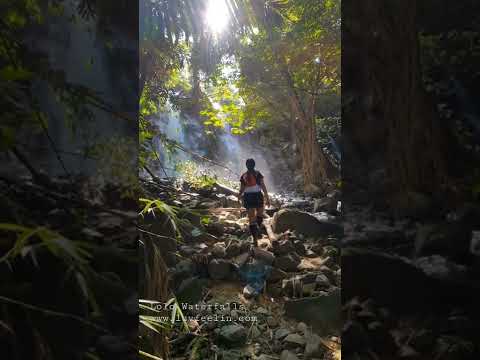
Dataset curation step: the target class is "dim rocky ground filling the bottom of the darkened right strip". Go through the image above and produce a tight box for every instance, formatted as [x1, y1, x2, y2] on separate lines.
[342, 204, 480, 359]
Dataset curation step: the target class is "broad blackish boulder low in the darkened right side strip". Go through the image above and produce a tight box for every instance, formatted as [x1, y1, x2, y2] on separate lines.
[342, 248, 480, 313]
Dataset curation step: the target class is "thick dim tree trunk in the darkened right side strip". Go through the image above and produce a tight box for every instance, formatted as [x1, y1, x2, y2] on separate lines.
[342, 0, 448, 207]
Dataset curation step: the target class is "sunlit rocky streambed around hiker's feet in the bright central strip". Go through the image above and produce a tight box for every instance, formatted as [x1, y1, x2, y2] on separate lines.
[143, 180, 343, 360]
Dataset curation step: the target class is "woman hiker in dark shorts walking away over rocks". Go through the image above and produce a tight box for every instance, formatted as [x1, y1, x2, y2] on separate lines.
[238, 159, 270, 246]
